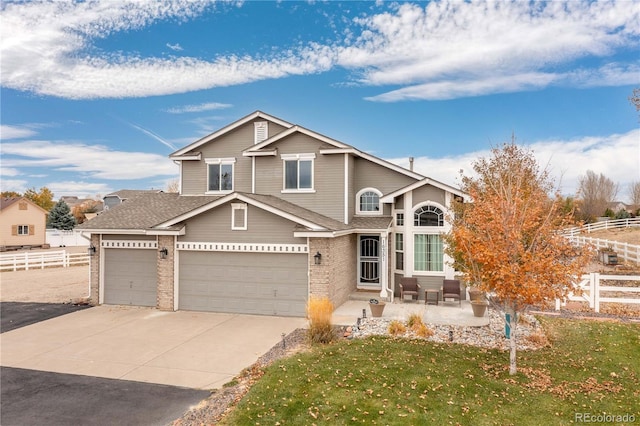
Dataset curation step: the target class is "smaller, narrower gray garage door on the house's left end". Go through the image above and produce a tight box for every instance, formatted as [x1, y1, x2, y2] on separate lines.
[104, 249, 158, 306]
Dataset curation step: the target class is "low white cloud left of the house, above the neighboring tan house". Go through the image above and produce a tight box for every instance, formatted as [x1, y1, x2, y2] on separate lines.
[2, 140, 178, 180]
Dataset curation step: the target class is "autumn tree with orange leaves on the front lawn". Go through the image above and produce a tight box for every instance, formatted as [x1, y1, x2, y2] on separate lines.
[445, 143, 591, 375]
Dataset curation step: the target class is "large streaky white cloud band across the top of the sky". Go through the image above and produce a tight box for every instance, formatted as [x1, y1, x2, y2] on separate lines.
[0, 0, 640, 100]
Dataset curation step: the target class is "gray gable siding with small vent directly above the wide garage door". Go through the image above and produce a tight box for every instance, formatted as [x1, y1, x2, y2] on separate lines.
[178, 203, 307, 244]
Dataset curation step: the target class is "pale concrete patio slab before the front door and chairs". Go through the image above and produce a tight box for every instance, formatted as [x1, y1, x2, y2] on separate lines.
[333, 300, 489, 327]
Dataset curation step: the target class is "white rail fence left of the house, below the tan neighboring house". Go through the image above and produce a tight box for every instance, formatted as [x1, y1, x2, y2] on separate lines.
[0, 250, 89, 272]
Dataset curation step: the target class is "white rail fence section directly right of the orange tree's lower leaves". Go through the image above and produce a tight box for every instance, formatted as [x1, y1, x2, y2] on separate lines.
[556, 272, 640, 312]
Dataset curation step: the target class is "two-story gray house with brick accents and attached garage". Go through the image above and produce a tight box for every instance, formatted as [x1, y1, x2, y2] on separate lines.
[80, 111, 464, 316]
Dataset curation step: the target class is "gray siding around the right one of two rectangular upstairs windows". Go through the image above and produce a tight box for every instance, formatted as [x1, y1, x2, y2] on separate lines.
[256, 133, 344, 221]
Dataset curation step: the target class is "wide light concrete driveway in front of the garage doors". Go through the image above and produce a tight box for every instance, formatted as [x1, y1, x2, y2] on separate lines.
[0, 305, 306, 389]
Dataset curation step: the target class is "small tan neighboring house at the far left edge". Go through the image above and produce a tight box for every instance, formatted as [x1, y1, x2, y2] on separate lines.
[0, 197, 47, 249]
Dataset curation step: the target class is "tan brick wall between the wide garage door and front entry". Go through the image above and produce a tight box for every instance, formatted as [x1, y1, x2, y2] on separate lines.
[309, 235, 357, 307]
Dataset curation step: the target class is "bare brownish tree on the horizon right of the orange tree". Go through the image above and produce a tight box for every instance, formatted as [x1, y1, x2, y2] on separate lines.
[578, 170, 618, 221]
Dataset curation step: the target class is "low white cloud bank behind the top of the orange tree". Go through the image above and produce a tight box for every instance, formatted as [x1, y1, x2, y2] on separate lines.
[389, 129, 640, 201]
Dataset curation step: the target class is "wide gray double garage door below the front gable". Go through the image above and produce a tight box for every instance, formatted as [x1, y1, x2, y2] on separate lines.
[178, 251, 308, 317]
